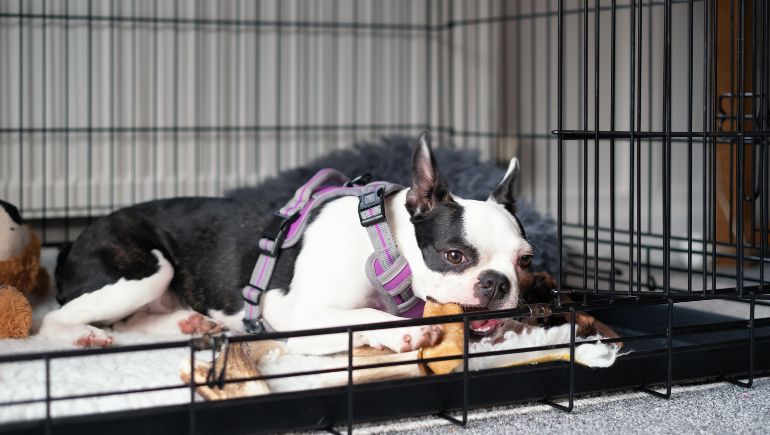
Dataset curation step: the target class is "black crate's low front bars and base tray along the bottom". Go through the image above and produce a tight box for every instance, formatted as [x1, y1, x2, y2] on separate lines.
[0, 301, 770, 433]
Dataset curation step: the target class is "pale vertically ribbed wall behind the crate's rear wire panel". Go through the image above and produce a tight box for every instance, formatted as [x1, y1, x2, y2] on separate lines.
[0, 0, 500, 217]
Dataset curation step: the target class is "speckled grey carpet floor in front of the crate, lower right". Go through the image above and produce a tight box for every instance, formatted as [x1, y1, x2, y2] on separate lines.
[316, 378, 770, 434]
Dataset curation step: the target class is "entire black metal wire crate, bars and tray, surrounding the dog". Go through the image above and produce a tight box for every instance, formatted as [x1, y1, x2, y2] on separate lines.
[0, 0, 770, 433]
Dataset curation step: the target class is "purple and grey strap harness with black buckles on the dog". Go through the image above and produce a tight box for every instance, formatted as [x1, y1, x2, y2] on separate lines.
[243, 168, 425, 333]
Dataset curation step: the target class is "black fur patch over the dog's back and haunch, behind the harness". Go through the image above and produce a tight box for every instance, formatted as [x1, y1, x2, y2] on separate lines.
[56, 198, 270, 314]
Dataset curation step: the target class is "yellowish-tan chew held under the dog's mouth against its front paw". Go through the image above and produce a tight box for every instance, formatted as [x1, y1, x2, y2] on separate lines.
[422, 302, 463, 375]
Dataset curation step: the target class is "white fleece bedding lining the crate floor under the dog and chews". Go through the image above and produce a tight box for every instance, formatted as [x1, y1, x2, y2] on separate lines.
[0, 250, 618, 424]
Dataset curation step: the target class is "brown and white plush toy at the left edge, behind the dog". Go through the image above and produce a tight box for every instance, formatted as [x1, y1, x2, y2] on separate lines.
[0, 200, 50, 339]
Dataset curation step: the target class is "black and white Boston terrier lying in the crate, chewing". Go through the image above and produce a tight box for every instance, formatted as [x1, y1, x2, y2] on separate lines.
[40, 134, 533, 353]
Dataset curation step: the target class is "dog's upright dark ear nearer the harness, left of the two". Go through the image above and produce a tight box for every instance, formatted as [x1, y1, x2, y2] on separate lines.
[406, 131, 450, 218]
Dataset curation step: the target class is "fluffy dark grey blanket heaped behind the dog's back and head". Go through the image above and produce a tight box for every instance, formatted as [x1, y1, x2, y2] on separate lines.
[227, 136, 559, 276]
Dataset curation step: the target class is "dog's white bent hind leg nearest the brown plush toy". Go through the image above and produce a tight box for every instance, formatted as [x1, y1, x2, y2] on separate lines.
[39, 250, 174, 347]
